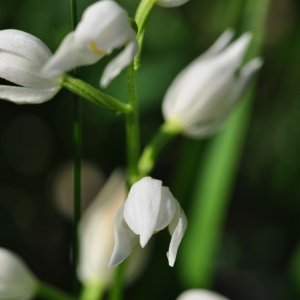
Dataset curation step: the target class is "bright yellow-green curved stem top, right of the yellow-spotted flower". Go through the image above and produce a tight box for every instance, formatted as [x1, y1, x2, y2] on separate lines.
[134, 0, 157, 70]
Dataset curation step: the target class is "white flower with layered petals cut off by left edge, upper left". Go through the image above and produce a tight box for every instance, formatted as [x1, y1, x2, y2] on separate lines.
[0, 29, 60, 104]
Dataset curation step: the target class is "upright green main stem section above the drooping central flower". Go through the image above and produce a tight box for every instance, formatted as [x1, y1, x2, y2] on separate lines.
[126, 64, 140, 186]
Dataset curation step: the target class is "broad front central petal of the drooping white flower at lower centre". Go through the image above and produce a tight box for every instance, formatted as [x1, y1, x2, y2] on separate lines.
[124, 177, 162, 248]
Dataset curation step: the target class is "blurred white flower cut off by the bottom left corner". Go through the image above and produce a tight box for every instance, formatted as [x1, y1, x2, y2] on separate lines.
[0, 248, 37, 300]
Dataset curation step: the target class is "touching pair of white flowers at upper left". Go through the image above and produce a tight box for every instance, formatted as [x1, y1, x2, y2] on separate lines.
[0, 0, 138, 104]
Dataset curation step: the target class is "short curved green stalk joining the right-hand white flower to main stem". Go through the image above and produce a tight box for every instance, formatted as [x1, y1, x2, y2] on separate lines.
[138, 123, 182, 178]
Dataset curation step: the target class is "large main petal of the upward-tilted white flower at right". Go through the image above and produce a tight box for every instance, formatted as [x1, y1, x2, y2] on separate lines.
[163, 33, 251, 129]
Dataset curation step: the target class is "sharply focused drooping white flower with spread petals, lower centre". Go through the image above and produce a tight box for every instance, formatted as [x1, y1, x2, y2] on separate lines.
[109, 177, 187, 267]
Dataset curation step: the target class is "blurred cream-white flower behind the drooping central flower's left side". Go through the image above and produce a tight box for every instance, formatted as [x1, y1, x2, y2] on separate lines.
[78, 170, 145, 286]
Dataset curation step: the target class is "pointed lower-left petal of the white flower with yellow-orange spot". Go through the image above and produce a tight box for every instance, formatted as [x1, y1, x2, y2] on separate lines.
[43, 32, 99, 76]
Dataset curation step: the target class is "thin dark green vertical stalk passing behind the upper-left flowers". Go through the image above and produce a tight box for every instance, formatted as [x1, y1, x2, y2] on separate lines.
[70, 0, 81, 288]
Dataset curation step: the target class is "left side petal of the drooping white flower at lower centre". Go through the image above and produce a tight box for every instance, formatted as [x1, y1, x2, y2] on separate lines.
[109, 205, 137, 267]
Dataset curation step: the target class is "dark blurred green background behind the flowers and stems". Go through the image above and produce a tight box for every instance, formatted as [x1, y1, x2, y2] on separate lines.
[0, 0, 300, 300]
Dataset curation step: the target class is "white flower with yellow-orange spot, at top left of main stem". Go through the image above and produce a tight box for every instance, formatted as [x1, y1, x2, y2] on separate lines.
[45, 0, 138, 87]
